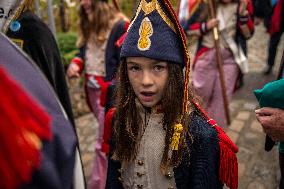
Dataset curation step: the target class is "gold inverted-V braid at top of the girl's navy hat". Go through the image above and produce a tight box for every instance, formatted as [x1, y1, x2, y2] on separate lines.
[128, 0, 176, 33]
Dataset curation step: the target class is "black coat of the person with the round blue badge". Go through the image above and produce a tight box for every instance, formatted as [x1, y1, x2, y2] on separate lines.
[6, 10, 75, 125]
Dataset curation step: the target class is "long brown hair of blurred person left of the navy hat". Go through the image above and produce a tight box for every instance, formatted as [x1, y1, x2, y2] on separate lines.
[76, 0, 117, 47]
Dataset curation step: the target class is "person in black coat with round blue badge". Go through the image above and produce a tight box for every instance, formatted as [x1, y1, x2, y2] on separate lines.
[3, 0, 75, 126]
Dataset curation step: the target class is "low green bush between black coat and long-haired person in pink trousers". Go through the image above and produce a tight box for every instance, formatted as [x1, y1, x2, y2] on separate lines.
[57, 32, 78, 65]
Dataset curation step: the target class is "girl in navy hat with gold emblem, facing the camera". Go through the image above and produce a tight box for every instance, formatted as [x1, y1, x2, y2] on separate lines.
[105, 0, 238, 189]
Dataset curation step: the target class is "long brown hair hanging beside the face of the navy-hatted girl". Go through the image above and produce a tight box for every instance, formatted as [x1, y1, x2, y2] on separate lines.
[113, 60, 195, 170]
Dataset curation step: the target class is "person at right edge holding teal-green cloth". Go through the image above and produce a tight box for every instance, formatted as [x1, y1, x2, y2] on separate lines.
[255, 51, 284, 188]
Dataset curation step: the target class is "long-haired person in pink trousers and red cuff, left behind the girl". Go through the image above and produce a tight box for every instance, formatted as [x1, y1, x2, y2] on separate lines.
[67, 0, 126, 189]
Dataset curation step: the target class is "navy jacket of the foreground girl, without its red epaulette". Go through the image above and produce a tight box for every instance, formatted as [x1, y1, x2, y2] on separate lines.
[106, 111, 223, 189]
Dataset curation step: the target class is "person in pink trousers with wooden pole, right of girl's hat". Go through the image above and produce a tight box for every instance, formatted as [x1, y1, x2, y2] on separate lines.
[189, 0, 254, 127]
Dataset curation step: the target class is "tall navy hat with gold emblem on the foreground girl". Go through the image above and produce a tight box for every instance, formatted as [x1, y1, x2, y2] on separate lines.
[120, 0, 188, 66]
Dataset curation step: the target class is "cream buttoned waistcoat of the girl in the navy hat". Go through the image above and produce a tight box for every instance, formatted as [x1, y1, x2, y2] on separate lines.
[121, 105, 176, 189]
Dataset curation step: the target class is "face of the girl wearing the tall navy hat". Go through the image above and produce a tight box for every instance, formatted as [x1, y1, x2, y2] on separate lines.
[126, 57, 169, 108]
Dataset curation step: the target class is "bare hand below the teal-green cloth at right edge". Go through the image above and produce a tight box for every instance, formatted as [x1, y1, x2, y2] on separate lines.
[255, 107, 284, 141]
